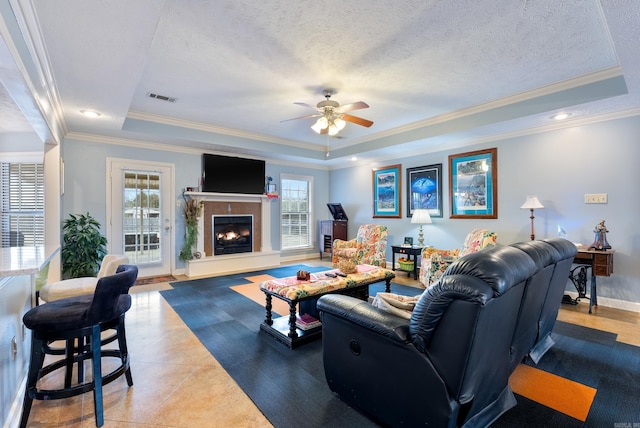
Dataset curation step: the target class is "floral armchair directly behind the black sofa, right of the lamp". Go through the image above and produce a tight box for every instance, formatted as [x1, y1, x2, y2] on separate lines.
[418, 229, 497, 287]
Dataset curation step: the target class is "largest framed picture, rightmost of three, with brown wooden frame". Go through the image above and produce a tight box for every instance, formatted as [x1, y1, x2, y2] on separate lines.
[449, 148, 498, 218]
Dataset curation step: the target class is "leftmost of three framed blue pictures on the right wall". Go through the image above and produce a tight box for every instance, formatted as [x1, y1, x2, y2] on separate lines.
[373, 165, 402, 218]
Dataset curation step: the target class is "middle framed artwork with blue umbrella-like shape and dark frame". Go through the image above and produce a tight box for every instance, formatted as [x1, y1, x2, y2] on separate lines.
[407, 163, 442, 217]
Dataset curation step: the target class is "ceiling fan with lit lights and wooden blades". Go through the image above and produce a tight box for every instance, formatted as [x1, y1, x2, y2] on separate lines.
[282, 89, 373, 136]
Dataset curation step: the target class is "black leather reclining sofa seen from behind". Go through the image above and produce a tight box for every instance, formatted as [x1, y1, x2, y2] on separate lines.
[318, 239, 576, 427]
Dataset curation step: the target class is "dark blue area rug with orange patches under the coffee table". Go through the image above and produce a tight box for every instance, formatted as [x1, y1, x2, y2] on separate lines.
[161, 265, 640, 427]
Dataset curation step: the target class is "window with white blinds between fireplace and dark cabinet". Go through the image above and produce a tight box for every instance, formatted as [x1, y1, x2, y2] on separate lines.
[280, 174, 313, 250]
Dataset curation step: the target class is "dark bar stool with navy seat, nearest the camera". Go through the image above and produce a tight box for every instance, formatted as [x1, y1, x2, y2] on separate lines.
[20, 265, 138, 428]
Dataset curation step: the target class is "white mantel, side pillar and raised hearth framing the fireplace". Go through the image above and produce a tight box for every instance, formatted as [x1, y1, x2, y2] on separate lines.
[184, 192, 280, 276]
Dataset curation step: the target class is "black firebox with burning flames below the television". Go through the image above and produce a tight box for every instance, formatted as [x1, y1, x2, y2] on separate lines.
[211, 215, 253, 255]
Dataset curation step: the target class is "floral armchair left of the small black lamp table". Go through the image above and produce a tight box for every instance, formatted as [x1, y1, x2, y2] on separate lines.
[332, 224, 388, 268]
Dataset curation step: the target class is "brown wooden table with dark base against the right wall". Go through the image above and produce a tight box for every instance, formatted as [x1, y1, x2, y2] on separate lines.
[563, 247, 615, 313]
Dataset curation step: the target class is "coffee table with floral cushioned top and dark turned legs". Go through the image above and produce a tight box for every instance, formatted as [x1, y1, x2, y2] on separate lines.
[260, 265, 395, 349]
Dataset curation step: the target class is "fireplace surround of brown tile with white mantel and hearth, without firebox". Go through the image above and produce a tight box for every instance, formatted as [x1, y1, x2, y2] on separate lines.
[185, 192, 280, 277]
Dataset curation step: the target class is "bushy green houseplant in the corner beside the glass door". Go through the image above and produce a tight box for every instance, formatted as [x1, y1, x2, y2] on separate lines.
[62, 212, 107, 278]
